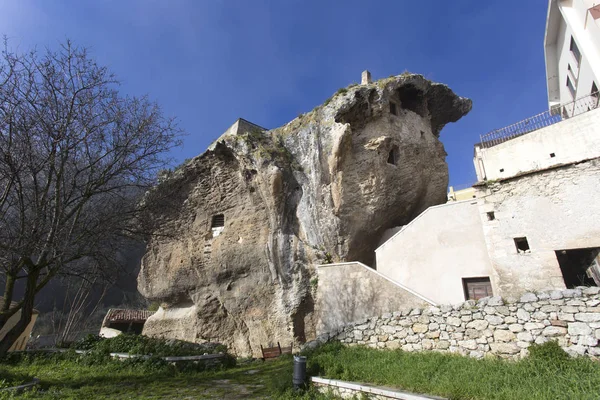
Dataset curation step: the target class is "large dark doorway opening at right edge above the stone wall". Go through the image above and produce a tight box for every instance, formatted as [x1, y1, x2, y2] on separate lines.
[555, 247, 600, 289]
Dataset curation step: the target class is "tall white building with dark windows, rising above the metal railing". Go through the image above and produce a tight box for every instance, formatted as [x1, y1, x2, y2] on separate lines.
[544, 0, 600, 108]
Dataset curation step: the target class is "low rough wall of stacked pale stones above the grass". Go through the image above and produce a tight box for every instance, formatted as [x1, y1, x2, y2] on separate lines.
[319, 287, 600, 359]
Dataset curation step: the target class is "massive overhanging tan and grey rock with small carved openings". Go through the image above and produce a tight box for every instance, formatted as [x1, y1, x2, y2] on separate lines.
[138, 74, 471, 355]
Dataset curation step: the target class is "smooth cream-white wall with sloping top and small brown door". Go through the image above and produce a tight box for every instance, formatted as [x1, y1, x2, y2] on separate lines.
[375, 200, 496, 304]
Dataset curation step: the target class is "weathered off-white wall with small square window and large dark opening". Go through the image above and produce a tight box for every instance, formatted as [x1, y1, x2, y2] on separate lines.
[480, 159, 600, 297]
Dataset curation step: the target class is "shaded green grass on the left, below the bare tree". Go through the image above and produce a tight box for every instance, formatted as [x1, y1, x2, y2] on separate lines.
[0, 353, 327, 400]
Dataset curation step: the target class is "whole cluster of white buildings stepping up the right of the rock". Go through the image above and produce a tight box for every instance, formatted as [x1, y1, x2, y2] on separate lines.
[316, 0, 600, 340]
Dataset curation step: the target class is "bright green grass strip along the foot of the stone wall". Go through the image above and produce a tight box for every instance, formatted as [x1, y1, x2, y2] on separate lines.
[308, 342, 600, 400]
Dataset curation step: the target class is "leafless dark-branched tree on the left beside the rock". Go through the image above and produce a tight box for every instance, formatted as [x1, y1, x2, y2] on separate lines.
[0, 41, 181, 356]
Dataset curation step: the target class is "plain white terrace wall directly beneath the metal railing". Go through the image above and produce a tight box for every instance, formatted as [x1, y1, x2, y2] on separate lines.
[474, 109, 600, 181]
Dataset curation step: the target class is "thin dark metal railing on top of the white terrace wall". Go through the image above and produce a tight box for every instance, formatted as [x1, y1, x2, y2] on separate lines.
[480, 92, 600, 148]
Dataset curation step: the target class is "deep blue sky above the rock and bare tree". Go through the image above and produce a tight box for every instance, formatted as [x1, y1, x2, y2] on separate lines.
[0, 0, 547, 187]
